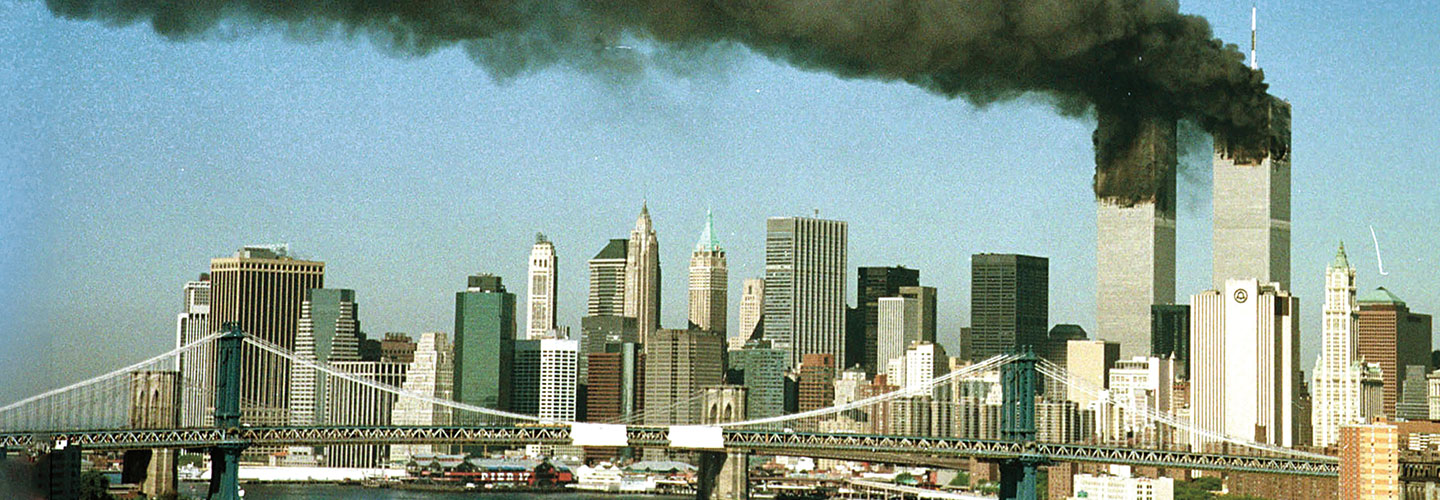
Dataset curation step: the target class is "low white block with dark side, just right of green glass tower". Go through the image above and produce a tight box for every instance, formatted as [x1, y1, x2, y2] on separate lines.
[510, 339, 580, 422]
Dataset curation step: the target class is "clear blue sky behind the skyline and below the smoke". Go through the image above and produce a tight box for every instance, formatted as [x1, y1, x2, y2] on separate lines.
[0, 0, 1440, 403]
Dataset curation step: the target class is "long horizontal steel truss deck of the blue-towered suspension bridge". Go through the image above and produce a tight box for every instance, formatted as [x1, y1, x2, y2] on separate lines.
[0, 425, 1336, 478]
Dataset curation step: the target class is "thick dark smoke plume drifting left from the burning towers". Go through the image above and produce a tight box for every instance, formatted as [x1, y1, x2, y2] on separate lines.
[46, 0, 1270, 199]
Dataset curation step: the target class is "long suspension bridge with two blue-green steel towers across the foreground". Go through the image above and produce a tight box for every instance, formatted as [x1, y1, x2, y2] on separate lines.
[0, 324, 1382, 499]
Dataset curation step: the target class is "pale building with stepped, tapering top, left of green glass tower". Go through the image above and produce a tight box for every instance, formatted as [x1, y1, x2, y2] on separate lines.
[390, 331, 455, 464]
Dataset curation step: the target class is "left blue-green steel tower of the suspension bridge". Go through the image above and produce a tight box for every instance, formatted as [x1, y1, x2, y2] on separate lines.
[209, 321, 245, 500]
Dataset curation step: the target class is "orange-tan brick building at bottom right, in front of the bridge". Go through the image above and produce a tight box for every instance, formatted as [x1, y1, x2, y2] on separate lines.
[1339, 418, 1401, 500]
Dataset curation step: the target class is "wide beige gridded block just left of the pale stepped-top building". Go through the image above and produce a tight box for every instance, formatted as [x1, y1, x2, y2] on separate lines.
[323, 362, 409, 467]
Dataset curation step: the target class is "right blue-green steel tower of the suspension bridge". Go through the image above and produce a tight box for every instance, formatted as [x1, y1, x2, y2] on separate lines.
[999, 346, 1044, 500]
